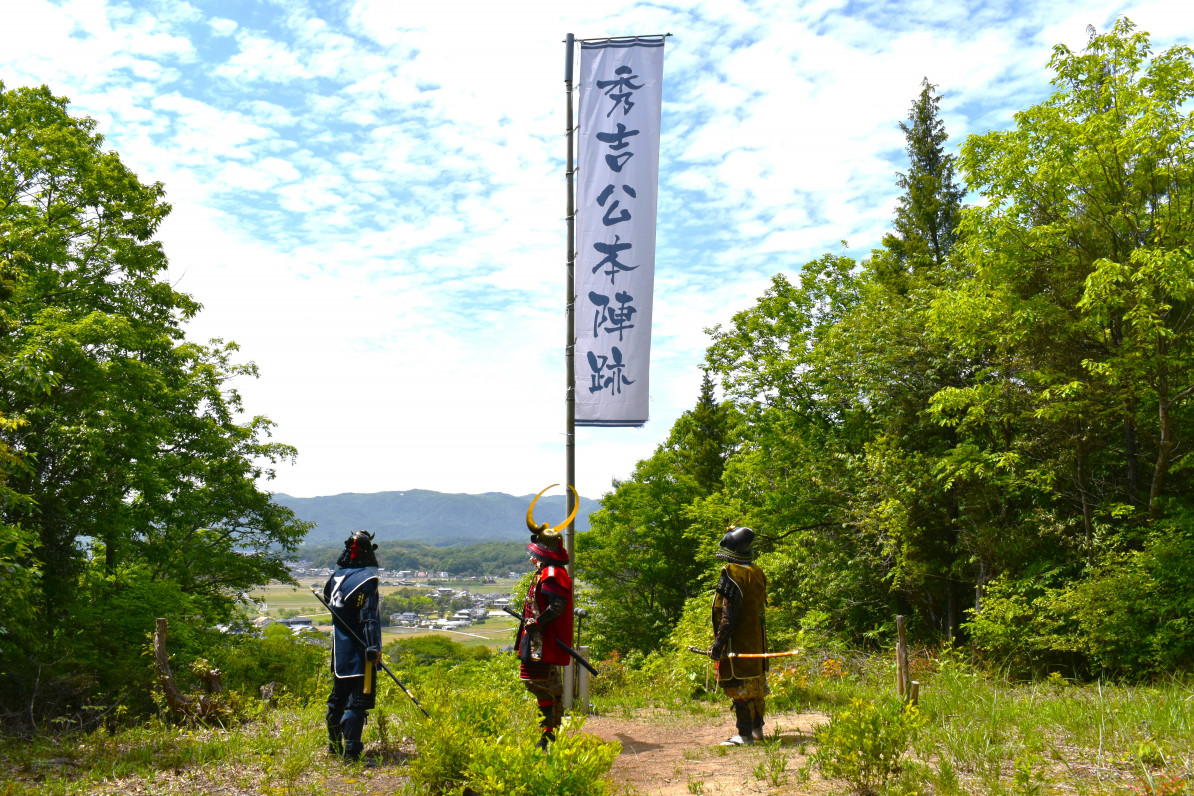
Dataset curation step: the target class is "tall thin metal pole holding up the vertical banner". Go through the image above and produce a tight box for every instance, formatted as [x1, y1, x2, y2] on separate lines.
[564, 33, 577, 709]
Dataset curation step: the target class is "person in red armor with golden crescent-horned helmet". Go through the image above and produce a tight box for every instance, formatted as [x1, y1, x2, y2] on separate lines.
[517, 485, 580, 749]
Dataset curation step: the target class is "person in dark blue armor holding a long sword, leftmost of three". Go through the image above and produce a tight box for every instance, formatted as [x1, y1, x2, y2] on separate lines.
[324, 531, 381, 760]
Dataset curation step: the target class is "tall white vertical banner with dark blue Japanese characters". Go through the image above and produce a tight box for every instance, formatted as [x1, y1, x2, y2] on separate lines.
[574, 37, 664, 426]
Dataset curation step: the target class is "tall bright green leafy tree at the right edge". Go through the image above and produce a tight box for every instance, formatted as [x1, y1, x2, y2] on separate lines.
[933, 19, 1194, 665]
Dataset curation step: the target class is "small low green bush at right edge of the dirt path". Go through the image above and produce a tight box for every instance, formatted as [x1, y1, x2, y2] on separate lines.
[813, 699, 923, 794]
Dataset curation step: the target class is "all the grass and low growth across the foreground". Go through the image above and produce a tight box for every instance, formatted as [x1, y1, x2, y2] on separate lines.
[0, 650, 1194, 796]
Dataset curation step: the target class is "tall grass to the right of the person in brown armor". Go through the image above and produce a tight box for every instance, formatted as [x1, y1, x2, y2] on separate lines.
[781, 654, 1194, 794]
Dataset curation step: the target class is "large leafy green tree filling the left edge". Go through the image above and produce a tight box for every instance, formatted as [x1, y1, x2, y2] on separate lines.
[0, 85, 306, 712]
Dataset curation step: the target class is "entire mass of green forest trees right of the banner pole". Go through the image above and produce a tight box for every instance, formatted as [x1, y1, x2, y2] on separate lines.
[578, 20, 1194, 675]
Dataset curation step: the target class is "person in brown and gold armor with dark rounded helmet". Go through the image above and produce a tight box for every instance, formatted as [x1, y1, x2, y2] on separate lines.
[709, 526, 767, 746]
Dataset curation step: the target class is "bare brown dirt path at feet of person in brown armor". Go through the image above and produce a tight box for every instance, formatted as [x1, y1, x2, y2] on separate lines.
[585, 712, 829, 796]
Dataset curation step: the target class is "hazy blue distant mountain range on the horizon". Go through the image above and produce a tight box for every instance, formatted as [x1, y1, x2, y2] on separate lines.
[273, 489, 601, 545]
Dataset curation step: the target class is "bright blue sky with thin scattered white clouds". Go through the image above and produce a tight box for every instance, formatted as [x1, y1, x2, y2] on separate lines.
[0, 0, 1194, 498]
